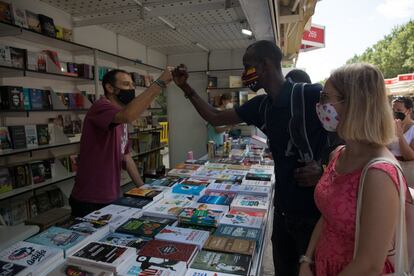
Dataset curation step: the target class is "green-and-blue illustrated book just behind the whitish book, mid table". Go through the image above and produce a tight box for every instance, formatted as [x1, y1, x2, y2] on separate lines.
[178, 206, 224, 226]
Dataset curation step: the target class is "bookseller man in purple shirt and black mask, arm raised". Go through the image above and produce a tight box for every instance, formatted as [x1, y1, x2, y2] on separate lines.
[69, 69, 172, 217]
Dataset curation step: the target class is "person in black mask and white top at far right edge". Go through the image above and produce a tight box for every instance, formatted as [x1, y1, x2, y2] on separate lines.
[388, 97, 414, 161]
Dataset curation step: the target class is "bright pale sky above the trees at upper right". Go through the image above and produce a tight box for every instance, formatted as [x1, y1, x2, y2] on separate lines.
[296, 0, 414, 82]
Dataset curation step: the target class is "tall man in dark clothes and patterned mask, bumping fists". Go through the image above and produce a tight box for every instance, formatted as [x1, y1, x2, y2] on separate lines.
[173, 40, 326, 276]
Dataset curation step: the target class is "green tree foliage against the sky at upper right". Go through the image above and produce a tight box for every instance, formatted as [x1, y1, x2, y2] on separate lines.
[346, 20, 414, 78]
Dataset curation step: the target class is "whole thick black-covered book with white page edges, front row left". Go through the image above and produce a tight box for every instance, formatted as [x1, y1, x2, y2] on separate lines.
[67, 242, 136, 273]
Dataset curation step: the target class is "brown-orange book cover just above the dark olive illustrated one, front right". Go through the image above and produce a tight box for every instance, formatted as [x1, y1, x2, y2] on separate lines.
[204, 236, 256, 256]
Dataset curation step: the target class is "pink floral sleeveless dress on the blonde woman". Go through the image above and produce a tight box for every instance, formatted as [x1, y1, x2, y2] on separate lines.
[315, 150, 398, 276]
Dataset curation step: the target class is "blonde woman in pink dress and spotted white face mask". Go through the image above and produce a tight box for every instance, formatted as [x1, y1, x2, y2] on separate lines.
[300, 64, 410, 276]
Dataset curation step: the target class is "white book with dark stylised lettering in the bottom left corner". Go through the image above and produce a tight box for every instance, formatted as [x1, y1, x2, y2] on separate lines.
[0, 241, 63, 275]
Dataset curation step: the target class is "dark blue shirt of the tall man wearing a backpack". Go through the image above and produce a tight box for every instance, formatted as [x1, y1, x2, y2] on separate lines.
[236, 81, 327, 217]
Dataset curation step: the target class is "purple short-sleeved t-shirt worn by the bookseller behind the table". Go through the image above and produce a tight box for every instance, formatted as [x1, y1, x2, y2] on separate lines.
[72, 98, 129, 203]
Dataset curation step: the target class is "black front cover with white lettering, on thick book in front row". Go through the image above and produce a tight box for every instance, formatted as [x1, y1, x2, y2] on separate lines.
[74, 242, 127, 263]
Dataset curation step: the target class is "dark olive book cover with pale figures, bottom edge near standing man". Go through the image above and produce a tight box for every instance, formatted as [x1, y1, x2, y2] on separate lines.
[190, 250, 251, 276]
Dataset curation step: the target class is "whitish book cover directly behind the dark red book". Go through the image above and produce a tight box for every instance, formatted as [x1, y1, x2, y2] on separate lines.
[155, 226, 210, 249]
